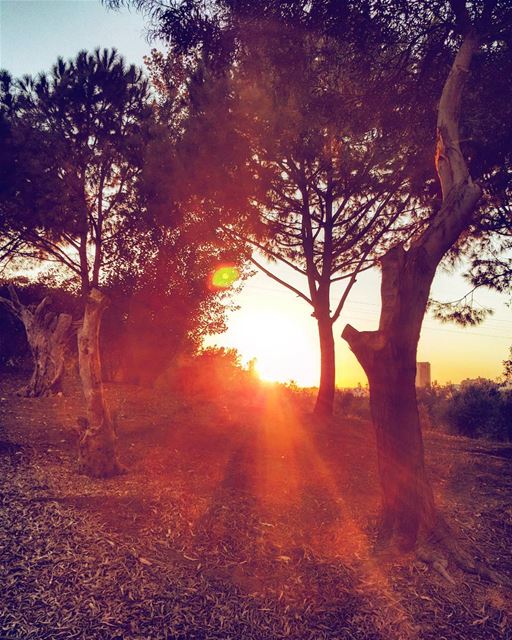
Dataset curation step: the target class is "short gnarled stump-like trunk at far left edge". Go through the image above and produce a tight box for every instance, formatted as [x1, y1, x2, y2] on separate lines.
[0, 285, 72, 398]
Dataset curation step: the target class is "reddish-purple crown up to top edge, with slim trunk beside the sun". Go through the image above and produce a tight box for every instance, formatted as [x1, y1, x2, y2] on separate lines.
[136, 2, 456, 410]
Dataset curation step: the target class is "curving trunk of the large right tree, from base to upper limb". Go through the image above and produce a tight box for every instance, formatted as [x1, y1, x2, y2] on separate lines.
[342, 32, 481, 549]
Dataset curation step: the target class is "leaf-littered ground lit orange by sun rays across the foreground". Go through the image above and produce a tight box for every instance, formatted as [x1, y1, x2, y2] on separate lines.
[0, 376, 512, 640]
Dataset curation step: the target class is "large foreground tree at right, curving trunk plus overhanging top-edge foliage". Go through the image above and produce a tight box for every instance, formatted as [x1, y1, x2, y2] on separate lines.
[110, 0, 512, 577]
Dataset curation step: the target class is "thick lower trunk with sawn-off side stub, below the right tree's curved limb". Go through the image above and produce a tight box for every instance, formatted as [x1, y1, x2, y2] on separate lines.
[342, 246, 437, 549]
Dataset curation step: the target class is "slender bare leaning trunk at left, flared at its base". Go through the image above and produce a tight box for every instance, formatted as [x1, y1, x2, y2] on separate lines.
[78, 289, 123, 478]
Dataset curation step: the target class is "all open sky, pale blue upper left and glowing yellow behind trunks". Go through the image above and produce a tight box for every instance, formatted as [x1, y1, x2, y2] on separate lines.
[0, 0, 512, 387]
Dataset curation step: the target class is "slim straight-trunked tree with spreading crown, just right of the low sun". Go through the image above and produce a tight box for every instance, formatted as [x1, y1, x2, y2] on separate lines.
[137, 7, 428, 415]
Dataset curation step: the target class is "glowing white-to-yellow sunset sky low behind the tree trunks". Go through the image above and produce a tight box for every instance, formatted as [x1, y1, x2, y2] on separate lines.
[207, 264, 512, 387]
